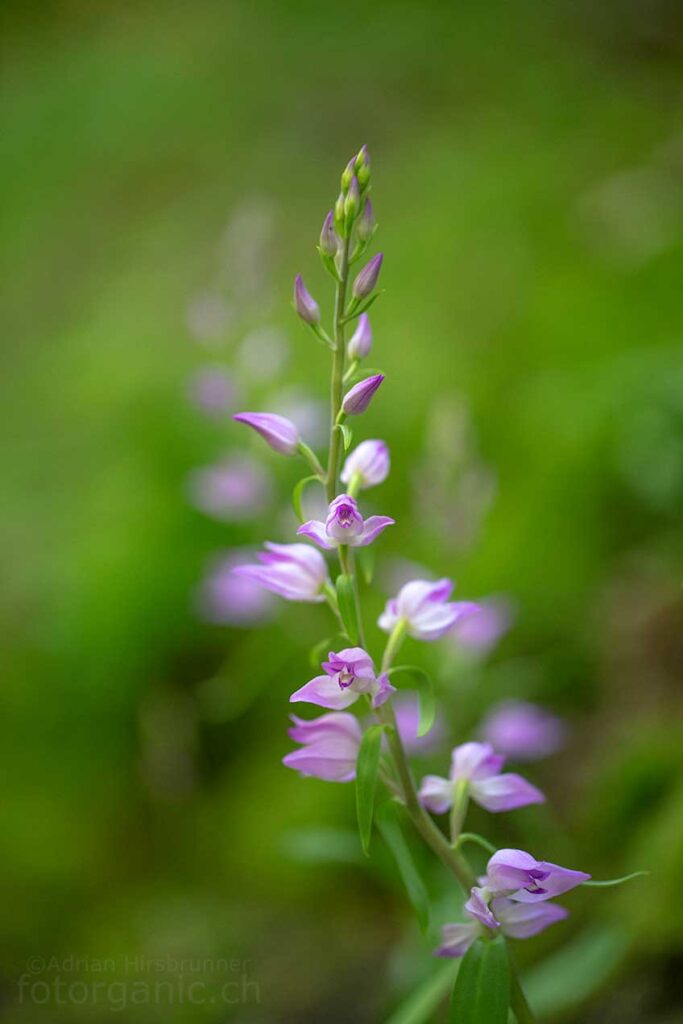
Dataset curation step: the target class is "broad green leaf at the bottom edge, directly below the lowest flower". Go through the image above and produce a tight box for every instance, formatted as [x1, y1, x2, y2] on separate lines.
[449, 935, 510, 1024]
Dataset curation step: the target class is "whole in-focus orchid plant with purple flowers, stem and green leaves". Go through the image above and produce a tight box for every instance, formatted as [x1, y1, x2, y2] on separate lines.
[233, 145, 643, 1024]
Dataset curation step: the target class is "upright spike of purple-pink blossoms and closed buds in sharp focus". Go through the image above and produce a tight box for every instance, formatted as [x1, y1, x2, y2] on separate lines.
[222, 146, 590, 1009]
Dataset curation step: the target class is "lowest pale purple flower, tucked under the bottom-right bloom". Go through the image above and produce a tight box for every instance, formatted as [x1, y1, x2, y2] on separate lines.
[436, 897, 568, 957]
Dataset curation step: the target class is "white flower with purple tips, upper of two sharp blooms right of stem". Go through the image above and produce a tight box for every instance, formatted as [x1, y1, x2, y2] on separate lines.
[378, 579, 479, 640]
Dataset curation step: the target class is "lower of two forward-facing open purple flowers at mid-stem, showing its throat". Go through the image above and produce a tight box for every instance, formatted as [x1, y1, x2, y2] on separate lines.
[290, 647, 396, 711]
